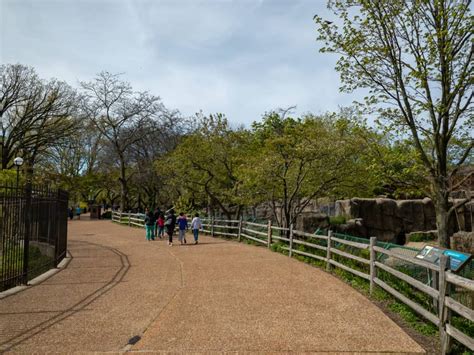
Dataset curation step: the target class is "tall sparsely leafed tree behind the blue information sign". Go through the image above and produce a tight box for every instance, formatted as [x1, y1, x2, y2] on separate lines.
[315, 0, 474, 247]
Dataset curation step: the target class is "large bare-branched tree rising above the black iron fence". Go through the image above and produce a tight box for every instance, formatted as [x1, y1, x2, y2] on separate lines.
[0, 64, 77, 173]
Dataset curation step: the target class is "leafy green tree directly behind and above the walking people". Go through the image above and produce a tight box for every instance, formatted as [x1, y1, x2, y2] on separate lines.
[166, 114, 248, 219]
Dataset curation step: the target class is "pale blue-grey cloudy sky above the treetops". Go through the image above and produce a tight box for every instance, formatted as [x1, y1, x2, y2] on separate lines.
[0, 0, 360, 125]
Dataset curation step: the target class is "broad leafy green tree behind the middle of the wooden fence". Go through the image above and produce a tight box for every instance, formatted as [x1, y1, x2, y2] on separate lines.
[241, 112, 356, 231]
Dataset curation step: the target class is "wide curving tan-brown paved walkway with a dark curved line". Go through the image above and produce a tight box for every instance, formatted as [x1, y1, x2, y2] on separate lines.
[0, 220, 423, 353]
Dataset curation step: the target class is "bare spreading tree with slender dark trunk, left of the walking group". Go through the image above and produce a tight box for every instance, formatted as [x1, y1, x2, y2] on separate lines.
[81, 72, 162, 210]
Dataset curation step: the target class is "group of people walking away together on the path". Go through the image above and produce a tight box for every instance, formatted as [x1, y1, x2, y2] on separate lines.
[145, 209, 202, 246]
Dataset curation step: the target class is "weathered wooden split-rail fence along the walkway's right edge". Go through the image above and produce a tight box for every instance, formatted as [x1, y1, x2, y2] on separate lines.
[112, 212, 474, 354]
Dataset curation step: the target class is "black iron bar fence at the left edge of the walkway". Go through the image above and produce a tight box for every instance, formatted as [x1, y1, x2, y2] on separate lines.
[0, 185, 68, 291]
